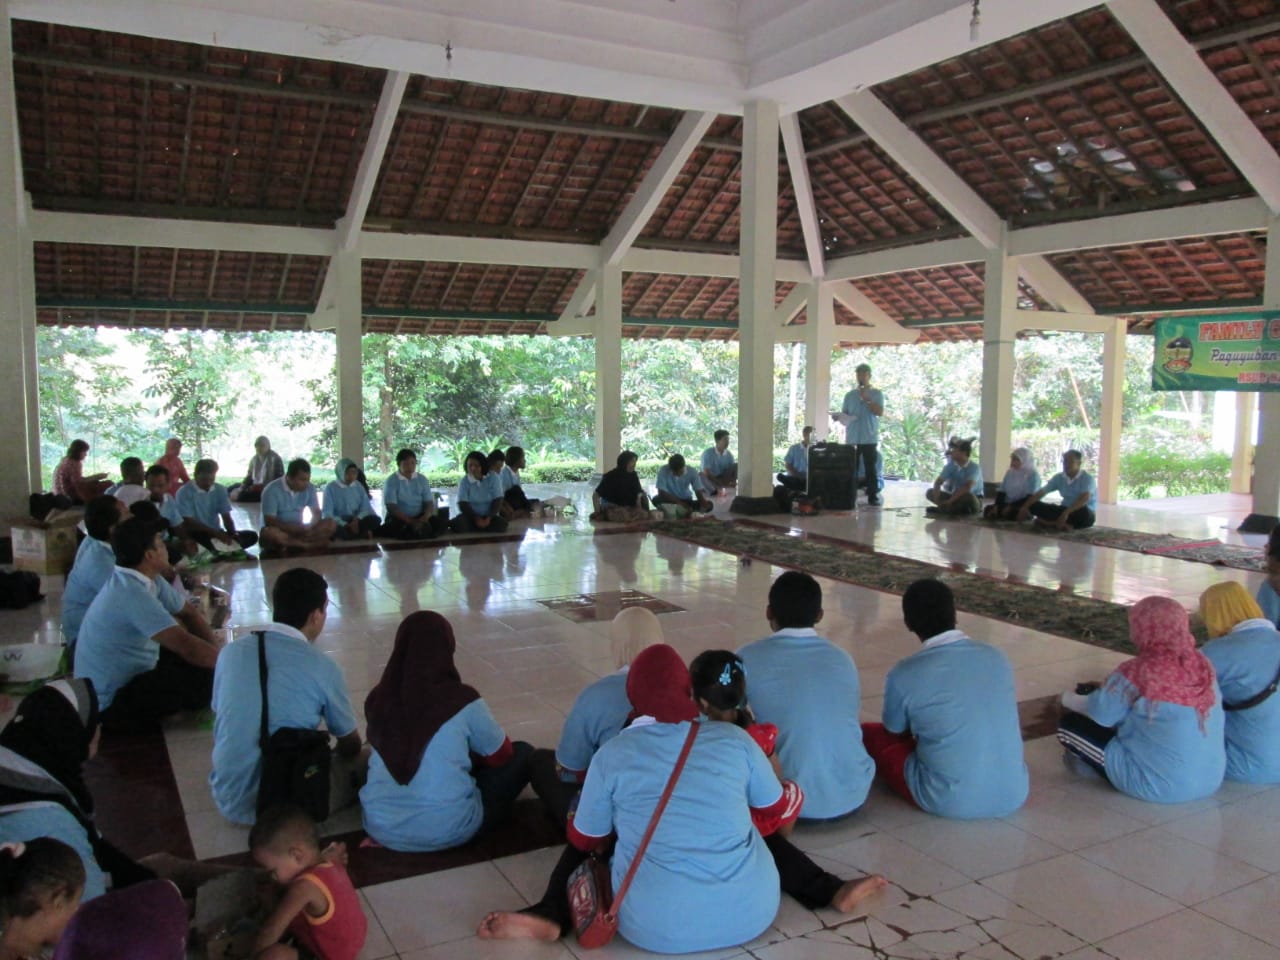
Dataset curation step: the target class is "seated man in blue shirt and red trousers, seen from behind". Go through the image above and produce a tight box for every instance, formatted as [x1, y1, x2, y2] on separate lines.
[860, 580, 1028, 819]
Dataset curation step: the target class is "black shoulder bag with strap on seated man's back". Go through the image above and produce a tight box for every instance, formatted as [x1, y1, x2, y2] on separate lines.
[253, 630, 330, 823]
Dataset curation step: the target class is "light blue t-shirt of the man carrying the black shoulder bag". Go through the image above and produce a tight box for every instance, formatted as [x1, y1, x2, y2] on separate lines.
[209, 623, 356, 823]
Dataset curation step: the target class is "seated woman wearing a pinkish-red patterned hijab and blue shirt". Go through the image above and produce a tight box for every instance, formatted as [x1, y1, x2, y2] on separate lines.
[1057, 596, 1226, 804]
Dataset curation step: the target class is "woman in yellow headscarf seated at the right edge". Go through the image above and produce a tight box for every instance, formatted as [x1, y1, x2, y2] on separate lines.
[1199, 581, 1280, 783]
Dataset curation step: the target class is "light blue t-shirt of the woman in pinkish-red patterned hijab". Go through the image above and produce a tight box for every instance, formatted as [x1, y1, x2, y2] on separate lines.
[1087, 673, 1223, 804]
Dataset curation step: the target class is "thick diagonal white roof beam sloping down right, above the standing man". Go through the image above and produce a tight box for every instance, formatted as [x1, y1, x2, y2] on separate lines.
[836, 90, 1004, 250]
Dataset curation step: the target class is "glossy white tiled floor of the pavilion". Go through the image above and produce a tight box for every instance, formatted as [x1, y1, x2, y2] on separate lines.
[0, 484, 1280, 960]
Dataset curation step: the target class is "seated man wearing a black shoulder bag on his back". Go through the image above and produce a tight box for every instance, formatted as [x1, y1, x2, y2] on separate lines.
[209, 567, 369, 823]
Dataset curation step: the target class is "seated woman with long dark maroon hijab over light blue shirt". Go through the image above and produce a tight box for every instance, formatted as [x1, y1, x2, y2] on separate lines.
[360, 611, 534, 851]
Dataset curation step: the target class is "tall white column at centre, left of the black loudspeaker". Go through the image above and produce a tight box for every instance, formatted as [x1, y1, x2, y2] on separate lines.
[737, 100, 778, 497]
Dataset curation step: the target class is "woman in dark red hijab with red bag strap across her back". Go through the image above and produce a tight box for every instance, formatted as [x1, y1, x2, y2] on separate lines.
[477, 644, 787, 954]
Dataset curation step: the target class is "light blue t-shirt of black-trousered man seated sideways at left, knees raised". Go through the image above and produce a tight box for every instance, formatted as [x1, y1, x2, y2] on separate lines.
[76, 567, 183, 710]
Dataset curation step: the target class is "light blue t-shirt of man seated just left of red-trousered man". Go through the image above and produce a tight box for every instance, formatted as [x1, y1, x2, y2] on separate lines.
[737, 627, 876, 819]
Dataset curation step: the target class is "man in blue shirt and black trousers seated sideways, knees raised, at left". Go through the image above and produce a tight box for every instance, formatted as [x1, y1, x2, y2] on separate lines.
[76, 517, 221, 733]
